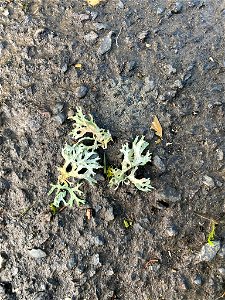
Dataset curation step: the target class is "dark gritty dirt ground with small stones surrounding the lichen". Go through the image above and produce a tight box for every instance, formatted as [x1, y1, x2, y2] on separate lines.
[0, 0, 225, 300]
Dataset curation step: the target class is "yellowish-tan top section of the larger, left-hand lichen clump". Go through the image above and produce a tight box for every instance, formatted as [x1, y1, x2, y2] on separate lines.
[69, 107, 112, 149]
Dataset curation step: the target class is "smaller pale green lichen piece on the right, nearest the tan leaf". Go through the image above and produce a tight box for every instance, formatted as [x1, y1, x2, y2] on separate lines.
[109, 136, 153, 192]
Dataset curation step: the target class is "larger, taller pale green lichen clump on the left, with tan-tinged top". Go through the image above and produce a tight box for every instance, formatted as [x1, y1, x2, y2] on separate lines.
[48, 108, 112, 207]
